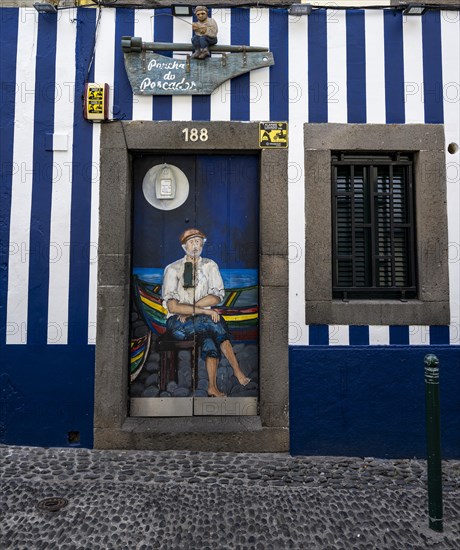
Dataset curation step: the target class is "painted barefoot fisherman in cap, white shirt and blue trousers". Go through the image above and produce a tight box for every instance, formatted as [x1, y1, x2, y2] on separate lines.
[162, 229, 250, 397]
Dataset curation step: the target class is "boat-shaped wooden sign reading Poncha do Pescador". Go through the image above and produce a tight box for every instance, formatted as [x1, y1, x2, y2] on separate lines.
[122, 37, 274, 95]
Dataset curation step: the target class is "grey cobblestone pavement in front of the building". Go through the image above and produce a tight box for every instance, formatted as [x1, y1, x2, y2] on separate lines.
[0, 446, 460, 550]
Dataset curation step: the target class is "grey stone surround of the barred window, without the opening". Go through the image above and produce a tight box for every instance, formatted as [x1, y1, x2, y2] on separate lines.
[304, 123, 450, 325]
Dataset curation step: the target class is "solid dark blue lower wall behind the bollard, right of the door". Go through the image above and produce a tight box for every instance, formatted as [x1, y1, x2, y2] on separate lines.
[289, 346, 460, 458]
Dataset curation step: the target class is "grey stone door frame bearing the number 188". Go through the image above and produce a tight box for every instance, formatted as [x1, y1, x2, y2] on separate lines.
[94, 121, 289, 452]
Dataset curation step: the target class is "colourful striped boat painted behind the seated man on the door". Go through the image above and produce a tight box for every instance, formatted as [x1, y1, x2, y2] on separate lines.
[132, 275, 259, 341]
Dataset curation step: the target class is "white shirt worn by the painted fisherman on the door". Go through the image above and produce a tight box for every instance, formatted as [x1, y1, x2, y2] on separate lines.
[162, 256, 225, 317]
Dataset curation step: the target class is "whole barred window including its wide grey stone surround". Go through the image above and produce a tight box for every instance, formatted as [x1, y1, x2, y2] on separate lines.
[304, 123, 450, 325]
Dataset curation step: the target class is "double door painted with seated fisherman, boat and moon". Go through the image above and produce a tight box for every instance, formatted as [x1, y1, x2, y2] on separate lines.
[130, 155, 259, 416]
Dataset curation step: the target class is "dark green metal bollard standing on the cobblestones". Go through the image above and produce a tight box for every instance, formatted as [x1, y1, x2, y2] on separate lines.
[425, 354, 443, 533]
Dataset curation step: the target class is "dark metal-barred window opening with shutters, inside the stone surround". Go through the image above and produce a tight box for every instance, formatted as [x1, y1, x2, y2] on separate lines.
[331, 152, 416, 300]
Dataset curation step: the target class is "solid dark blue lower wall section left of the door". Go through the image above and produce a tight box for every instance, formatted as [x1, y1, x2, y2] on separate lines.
[0, 345, 95, 447]
